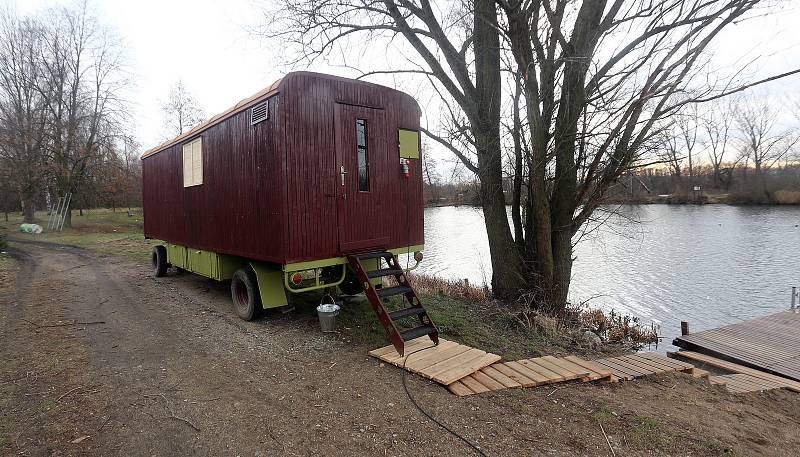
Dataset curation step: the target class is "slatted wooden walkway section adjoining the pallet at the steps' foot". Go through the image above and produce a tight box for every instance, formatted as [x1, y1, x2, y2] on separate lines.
[447, 356, 618, 397]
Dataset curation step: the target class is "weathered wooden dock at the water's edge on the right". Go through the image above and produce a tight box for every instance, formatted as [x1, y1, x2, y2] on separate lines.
[672, 310, 800, 381]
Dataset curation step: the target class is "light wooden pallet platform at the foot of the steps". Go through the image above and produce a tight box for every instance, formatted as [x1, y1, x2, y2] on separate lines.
[369, 336, 501, 386]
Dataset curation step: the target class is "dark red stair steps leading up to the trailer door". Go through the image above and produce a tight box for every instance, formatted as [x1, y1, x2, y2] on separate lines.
[347, 252, 439, 356]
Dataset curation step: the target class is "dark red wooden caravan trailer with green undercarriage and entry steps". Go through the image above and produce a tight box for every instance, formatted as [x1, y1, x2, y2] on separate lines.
[142, 72, 437, 353]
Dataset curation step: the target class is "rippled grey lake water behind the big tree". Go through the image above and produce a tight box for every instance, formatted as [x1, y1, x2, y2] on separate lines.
[412, 205, 800, 350]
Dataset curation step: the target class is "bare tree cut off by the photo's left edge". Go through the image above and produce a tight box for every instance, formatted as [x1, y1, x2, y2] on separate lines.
[0, 10, 47, 222]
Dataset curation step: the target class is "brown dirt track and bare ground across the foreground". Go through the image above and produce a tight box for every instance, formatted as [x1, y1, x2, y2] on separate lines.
[0, 243, 800, 456]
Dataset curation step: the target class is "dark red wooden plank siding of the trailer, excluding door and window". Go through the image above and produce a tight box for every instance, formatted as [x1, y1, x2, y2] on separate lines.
[142, 72, 423, 263]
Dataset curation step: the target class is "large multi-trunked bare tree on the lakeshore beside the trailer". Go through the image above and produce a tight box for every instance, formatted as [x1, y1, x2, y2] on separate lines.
[264, 0, 800, 310]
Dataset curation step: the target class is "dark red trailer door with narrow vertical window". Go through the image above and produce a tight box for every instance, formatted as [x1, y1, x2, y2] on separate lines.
[334, 103, 389, 253]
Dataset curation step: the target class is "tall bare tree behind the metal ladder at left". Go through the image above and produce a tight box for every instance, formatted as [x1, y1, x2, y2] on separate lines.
[41, 2, 128, 226]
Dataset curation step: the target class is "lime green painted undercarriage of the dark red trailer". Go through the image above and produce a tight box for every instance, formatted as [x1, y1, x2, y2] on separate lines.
[164, 239, 423, 308]
